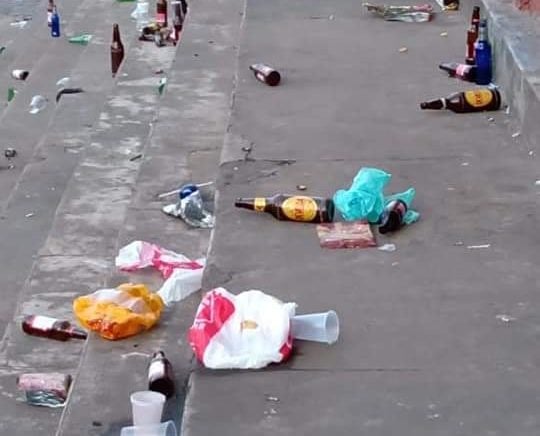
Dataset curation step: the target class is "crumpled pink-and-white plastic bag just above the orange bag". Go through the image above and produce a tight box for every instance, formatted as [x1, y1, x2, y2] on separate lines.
[115, 241, 204, 279]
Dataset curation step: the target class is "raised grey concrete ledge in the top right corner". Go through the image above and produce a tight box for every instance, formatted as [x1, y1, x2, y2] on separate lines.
[482, 0, 540, 144]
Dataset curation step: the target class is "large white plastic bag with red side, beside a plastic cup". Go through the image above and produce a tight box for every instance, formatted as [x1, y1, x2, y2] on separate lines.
[188, 288, 296, 369]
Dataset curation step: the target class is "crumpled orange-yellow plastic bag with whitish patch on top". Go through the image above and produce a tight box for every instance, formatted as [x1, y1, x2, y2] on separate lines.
[73, 283, 163, 340]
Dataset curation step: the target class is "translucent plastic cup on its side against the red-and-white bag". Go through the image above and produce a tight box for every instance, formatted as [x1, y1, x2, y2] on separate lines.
[291, 310, 339, 344]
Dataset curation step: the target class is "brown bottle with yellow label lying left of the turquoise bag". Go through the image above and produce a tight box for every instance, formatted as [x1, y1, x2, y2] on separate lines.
[234, 194, 334, 223]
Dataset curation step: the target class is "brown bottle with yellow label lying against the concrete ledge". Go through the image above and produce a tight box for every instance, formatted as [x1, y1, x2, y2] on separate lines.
[420, 88, 501, 113]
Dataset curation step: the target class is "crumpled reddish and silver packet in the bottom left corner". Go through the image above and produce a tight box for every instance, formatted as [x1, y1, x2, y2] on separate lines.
[17, 372, 71, 408]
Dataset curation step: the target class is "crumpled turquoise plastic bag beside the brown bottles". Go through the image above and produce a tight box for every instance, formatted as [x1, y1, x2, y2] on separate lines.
[334, 168, 420, 224]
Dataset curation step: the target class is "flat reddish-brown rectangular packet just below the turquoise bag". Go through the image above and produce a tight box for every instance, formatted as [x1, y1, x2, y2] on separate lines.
[317, 221, 377, 248]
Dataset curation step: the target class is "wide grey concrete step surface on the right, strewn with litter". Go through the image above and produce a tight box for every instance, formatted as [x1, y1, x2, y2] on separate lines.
[182, 0, 540, 436]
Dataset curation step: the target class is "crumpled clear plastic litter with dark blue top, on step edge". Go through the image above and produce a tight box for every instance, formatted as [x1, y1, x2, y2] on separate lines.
[162, 184, 215, 229]
